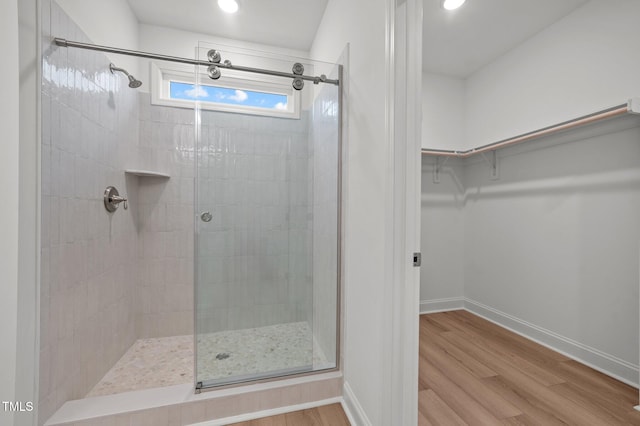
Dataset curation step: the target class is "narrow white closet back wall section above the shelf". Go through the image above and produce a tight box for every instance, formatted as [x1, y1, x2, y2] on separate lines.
[422, 72, 466, 149]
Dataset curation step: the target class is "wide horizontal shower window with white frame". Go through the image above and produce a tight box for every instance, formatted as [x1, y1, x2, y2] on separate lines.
[151, 63, 300, 119]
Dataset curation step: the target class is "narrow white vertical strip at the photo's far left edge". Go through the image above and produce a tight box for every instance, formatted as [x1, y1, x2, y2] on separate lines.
[0, 0, 20, 424]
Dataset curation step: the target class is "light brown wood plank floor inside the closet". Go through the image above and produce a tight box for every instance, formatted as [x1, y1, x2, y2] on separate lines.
[418, 311, 640, 426]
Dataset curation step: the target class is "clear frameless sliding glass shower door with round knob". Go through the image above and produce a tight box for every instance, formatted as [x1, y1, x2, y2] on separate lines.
[195, 43, 339, 388]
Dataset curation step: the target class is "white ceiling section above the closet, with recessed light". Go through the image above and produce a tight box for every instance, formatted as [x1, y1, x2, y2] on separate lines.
[422, 0, 587, 78]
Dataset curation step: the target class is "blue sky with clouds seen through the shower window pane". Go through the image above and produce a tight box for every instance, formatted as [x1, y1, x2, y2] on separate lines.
[169, 81, 287, 110]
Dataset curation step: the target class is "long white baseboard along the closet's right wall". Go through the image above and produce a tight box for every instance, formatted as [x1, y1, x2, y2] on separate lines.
[464, 298, 639, 388]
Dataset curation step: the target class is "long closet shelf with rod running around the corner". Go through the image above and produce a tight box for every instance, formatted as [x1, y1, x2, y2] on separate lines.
[422, 98, 640, 158]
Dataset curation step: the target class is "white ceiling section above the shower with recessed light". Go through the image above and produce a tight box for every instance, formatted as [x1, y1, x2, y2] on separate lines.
[128, 0, 327, 51]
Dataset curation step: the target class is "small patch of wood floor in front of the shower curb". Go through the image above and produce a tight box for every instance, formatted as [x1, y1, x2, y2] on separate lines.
[229, 404, 350, 426]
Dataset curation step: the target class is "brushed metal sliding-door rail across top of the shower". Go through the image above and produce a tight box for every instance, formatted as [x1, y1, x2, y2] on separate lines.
[53, 37, 340, 86]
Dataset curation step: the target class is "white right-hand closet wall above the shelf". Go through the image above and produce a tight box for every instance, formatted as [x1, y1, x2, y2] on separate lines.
[458, 0, 640, 149]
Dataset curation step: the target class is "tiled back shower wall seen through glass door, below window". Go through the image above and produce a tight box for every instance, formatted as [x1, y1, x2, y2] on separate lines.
[196, 111, 312, 333]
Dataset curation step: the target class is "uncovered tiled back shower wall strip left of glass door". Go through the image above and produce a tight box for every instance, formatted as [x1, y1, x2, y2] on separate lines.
[135, 93, 195, 338]
